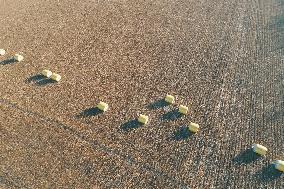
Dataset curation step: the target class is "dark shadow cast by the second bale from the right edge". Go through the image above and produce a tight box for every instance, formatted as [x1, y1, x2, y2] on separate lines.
[233, 149, 261, 165]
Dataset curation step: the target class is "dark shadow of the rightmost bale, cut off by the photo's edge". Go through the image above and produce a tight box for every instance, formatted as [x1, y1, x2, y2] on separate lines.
[255, 164, 283, 182]
